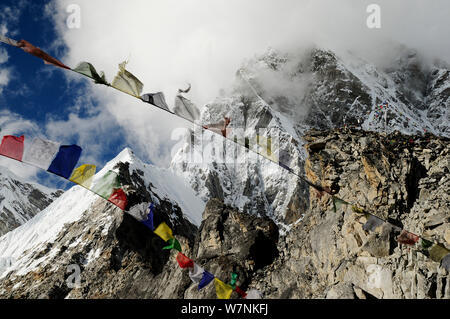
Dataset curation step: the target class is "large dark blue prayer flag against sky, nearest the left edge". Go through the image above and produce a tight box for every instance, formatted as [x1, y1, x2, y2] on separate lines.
[47, 145, 81, 179]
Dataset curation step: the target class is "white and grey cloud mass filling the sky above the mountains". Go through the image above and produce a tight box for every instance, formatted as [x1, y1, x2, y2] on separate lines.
[46, 0, 450, 166]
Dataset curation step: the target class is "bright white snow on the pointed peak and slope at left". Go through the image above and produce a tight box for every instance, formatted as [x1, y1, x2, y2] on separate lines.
[0, 148, 205, 277]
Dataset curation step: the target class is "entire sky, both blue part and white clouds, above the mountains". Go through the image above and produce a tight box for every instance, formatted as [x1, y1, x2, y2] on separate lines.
[0, 0, 450, 188]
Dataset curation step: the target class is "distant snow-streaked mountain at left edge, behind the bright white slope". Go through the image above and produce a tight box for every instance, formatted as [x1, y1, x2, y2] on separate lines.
[0, 166, 63, 236]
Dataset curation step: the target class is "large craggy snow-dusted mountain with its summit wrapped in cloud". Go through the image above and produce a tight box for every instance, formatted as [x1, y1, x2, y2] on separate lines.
[171, 49, 450, 229]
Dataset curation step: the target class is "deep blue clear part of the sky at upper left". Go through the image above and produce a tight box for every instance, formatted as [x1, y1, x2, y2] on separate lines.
[0, 0, 128, 188]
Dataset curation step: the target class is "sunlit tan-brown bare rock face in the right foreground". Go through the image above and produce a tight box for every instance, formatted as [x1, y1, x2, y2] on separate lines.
[252, 131, 450, 298]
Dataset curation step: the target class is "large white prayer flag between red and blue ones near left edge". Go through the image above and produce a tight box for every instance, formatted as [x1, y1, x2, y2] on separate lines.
[22, 137, 60, 170]
